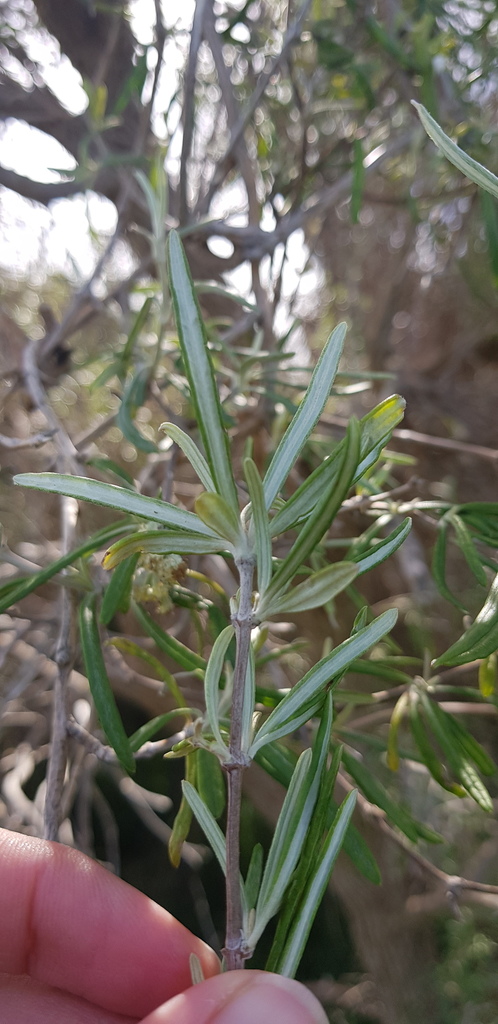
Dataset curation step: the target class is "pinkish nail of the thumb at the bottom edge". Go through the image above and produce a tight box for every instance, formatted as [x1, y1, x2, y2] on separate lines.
[213, 972, 327, 1024]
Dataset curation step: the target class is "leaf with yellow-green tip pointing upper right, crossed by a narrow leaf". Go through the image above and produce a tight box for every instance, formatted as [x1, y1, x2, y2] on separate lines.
[271, 394, 405, 537]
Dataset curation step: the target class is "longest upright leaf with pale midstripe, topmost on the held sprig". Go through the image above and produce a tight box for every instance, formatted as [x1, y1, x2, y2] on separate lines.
[168, 231, 239, 513]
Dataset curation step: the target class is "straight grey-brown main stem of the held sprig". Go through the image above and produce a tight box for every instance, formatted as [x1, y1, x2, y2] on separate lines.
[223, 556, 254, 971]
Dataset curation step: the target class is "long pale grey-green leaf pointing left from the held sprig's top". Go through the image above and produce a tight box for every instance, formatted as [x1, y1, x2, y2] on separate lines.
[13, 473, 220, 538]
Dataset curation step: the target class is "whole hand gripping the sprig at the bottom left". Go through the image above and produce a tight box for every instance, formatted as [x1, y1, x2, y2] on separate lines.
[0, 829, 326, 1024]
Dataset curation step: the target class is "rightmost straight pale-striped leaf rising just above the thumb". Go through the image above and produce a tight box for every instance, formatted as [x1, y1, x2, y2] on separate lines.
[278, 792, 357, 978]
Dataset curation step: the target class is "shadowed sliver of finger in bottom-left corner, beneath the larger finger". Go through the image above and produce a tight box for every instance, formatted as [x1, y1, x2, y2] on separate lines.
[0, 975, 137, 1024]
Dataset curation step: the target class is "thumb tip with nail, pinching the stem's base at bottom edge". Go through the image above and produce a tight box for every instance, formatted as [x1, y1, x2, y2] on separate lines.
[141, 971, 327, 1024]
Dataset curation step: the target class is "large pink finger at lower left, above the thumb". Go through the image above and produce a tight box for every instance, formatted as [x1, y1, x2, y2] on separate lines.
[0, 829, 219, 1018]
